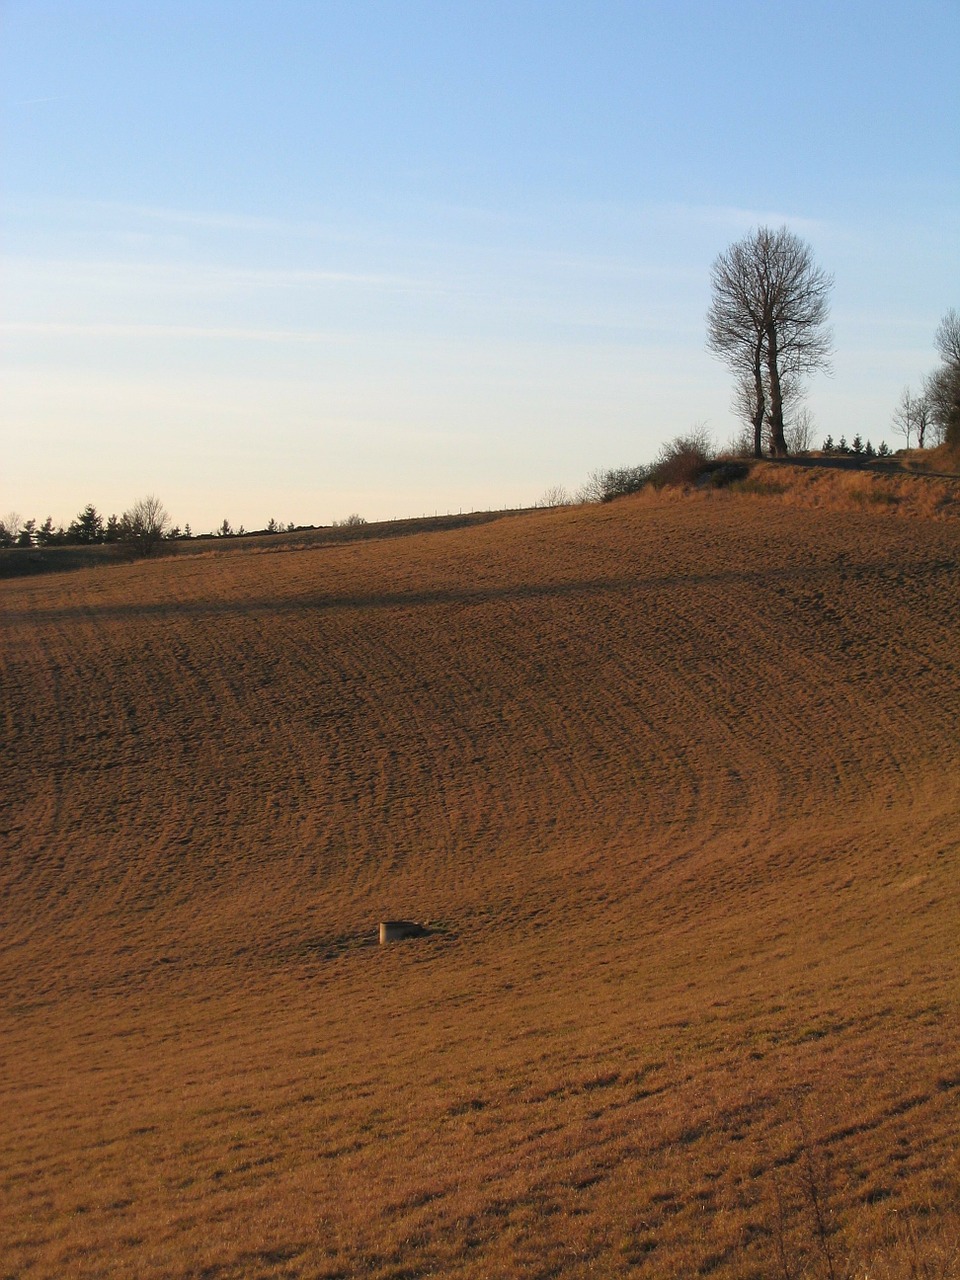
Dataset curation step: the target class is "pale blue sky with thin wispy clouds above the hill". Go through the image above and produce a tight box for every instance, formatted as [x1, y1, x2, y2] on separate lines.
[0, 0, 960, 532]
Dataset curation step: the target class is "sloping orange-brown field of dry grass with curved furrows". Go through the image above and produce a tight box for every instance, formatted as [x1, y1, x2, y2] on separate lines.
[0, 491, 960, 1280]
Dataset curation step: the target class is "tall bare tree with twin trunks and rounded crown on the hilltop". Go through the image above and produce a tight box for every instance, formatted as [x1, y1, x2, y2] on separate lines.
[707, 227, 833, 457]
